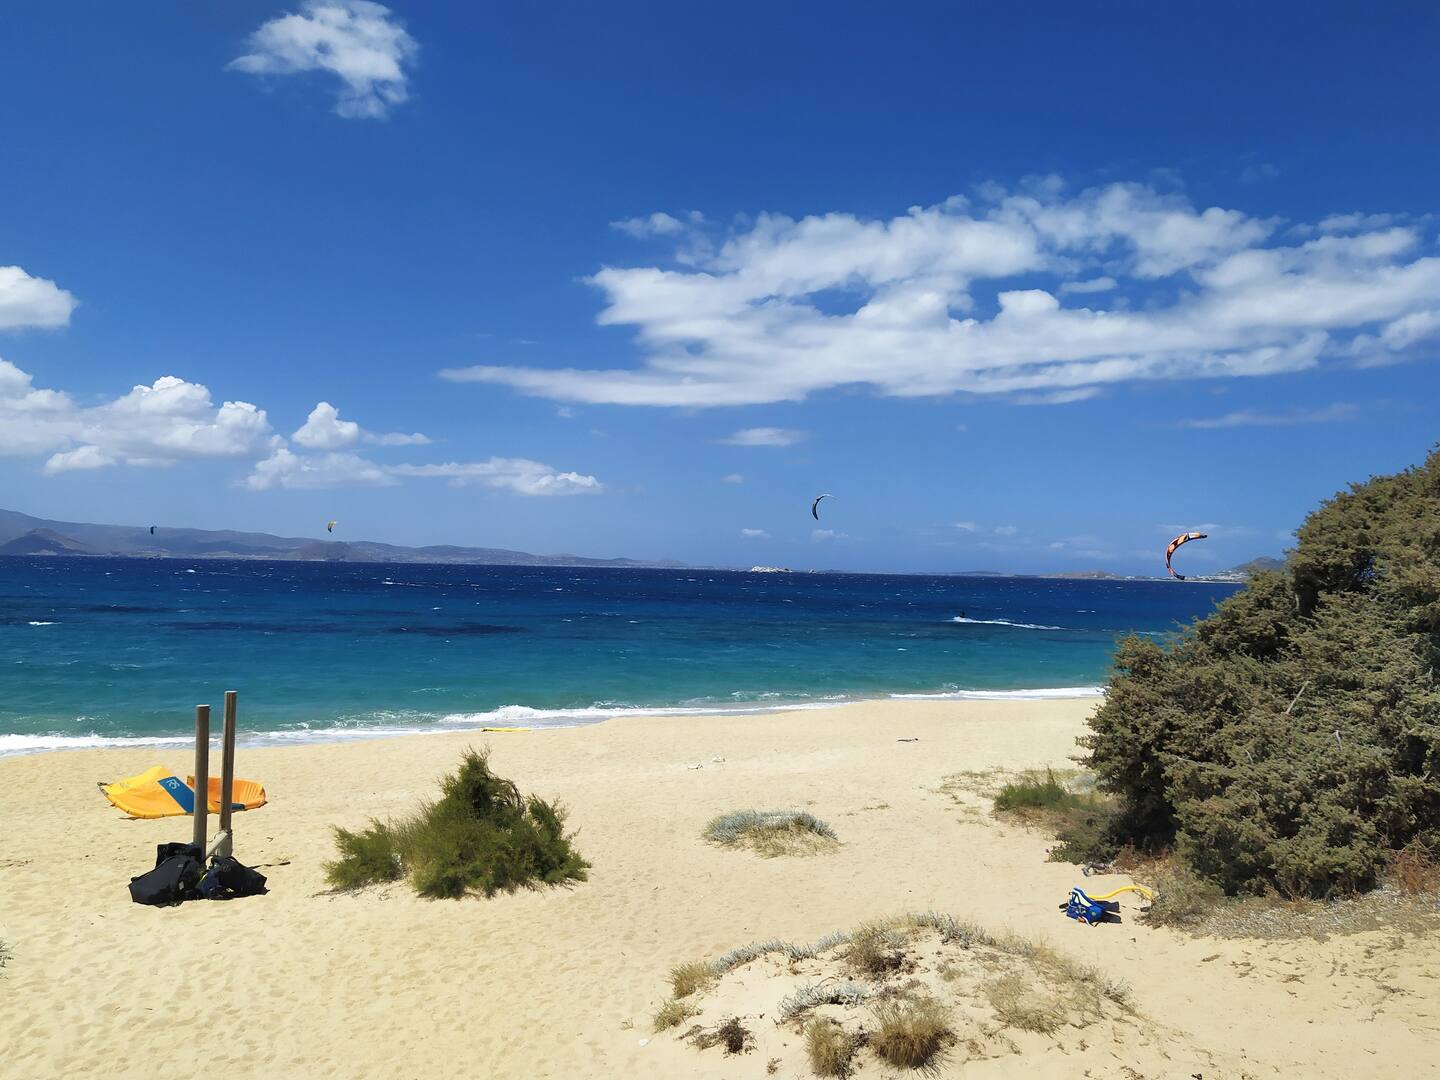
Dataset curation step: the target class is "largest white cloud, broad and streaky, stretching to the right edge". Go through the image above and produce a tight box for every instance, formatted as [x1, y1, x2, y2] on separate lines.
[442, 181, 1440, 408]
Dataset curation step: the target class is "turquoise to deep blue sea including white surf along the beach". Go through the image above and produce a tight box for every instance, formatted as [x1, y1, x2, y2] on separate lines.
[0, 557, 1236, 753]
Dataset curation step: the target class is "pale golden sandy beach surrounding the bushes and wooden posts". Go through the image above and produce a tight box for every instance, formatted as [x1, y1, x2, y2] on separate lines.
[0, 700, 1440, 1080]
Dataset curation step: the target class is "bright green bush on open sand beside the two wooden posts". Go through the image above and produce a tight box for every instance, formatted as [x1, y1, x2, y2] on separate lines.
[325, 750, 589, 899]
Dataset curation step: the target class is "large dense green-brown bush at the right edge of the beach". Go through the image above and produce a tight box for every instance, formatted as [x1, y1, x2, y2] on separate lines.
[1083, 451, 1440, 897]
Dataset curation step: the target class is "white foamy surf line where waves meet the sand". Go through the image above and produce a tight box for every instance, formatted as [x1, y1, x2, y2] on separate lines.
[0, 685, 1104, 760]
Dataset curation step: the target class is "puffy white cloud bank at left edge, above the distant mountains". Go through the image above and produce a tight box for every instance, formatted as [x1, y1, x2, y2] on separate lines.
[0, 360, 275, 474]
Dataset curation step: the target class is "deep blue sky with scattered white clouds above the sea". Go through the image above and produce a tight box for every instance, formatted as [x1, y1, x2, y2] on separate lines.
[0, 0, 1440, 572]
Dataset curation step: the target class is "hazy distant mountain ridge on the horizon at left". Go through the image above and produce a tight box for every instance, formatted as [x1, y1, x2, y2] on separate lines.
[0, 510, 683, 566]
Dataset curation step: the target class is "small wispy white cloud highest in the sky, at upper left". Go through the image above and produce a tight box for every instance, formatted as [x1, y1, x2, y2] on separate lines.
[229, 0, 419, 120]
